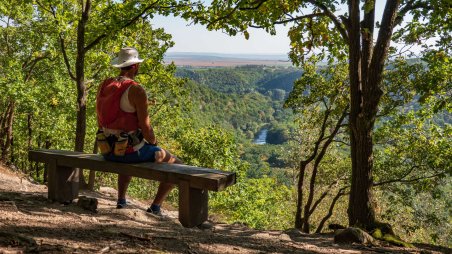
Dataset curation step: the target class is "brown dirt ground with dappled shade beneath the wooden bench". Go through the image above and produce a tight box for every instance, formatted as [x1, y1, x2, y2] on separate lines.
[0, 166, 452, 254]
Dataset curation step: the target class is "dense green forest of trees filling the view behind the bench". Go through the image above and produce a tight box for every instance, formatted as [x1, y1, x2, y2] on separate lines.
[0, 0, 452, 250]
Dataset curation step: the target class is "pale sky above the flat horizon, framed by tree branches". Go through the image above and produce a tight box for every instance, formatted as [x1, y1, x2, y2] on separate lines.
[152, 1, 384, 55]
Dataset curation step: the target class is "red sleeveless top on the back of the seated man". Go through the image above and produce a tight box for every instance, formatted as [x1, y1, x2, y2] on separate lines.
[96, 77, 138, 132]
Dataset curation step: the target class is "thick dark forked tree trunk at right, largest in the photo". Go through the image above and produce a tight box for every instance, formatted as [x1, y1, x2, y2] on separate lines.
[348, 0, 401, 229]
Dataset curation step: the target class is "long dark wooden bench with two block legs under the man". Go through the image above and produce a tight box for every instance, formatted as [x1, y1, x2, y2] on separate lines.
[28, 149, 236, 227]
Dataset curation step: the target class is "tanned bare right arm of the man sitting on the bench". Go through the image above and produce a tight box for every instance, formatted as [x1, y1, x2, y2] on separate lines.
[129, 85, 157, 144]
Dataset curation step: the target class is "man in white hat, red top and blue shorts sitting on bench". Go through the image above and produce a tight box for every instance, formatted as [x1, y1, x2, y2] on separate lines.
[96, 48, 182, 215]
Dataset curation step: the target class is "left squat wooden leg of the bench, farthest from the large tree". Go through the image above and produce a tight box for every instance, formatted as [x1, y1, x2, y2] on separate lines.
[48, 160, 79, 203]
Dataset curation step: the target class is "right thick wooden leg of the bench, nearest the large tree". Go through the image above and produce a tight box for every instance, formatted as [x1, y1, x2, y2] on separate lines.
[179, 181, 209, 228]
